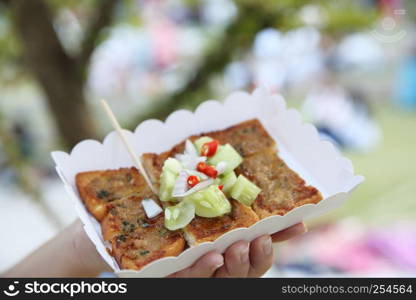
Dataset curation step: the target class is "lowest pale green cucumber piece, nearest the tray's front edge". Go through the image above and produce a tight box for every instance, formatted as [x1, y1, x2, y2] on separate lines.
[165, 201, 195, 230]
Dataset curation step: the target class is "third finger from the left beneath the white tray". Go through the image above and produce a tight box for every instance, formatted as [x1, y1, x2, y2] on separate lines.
[248, 235, 273, 277]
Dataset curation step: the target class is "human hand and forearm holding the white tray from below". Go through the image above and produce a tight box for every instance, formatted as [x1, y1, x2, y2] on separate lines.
[1, 220, 306, 277]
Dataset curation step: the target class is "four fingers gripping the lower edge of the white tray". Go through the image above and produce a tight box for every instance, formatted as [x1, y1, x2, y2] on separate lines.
[169, 223, 306, 277]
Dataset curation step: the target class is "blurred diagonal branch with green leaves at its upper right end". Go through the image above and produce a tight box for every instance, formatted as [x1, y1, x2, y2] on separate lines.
[129, 0, 376, 128]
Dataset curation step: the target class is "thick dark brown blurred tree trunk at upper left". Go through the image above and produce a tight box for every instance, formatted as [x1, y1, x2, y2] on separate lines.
[10, 0, 96, 147]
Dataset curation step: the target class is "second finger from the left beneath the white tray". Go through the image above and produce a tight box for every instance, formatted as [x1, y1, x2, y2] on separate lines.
[215, 241, 250, 277]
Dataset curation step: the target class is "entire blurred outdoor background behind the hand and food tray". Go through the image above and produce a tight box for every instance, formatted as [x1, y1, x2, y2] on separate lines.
[0, 0, 416, 276]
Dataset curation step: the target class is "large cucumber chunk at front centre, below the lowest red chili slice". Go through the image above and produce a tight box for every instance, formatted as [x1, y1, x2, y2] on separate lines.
[184, 185, 231, 218]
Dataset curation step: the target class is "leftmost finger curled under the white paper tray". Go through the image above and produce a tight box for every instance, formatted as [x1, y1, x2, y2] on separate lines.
[169, 252, 224, 278]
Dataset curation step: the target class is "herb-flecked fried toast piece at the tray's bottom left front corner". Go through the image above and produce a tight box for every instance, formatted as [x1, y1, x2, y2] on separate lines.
[101, 193, 185, 270]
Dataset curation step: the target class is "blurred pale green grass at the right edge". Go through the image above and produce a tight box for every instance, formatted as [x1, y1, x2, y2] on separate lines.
[312, 105, 416, 225]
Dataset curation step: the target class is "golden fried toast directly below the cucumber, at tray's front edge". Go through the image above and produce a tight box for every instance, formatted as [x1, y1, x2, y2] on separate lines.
[184, 199, 259, 246]
